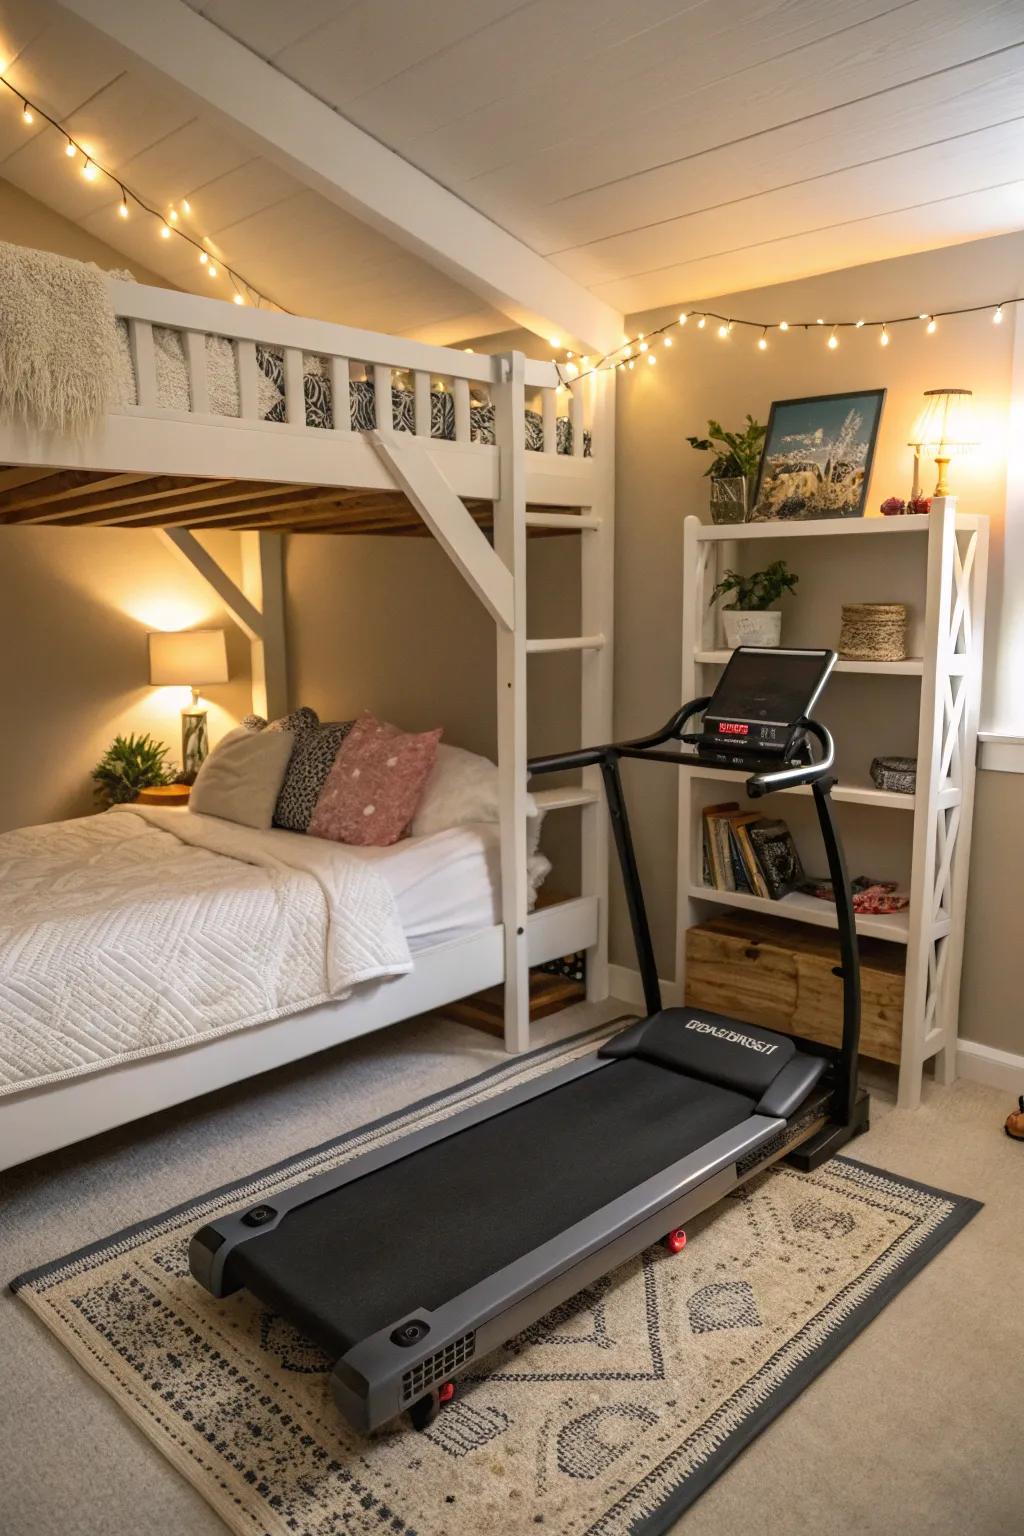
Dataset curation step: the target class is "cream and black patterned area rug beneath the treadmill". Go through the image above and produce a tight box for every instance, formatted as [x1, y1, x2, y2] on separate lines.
[14, 1028, 979, 1536]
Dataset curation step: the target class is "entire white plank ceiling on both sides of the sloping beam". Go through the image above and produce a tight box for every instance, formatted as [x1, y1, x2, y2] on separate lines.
[0, 0, 1024, 341]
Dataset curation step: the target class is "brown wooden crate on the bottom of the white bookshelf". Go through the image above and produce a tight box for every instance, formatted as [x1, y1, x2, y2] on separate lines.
[686, 912, 906, 1063]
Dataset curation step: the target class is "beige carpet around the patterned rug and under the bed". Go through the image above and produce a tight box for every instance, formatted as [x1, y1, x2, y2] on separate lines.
[0, 1003, 1024, 1536]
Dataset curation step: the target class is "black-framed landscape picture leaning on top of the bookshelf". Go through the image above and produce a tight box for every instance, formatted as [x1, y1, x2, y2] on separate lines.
[751, 389, 886, 522]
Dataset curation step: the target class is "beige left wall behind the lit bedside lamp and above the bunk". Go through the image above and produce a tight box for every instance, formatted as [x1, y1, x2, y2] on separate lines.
[0, 181, 250, 831]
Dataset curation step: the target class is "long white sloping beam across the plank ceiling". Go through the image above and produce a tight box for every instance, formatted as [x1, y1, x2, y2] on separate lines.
[61, 0, 622, 352]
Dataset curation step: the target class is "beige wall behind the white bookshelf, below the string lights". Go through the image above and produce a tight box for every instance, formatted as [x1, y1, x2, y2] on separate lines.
[613, 235, 1024, 1051]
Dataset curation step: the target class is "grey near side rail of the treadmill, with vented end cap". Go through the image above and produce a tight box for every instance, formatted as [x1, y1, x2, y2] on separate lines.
[332, 1115, 786, 1433]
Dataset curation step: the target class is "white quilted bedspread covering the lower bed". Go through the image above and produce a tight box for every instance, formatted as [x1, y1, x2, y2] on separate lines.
[0, 806, 411, 1095]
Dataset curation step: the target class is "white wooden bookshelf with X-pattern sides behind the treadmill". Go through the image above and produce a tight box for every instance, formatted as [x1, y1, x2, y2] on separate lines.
[676, 496, 989, 1107]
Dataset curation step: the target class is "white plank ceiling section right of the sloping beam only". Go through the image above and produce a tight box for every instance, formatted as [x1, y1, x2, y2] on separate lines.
[181, 0, 1024, 312]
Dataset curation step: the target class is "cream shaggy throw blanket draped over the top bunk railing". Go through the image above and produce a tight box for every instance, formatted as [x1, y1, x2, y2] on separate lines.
[0, 241, 118, 435]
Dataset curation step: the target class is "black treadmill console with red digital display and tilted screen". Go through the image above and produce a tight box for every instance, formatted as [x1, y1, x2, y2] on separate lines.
[697, 645, 835, 768]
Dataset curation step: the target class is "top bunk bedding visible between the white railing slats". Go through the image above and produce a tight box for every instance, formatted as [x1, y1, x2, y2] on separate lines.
[117, 319, 591, 458]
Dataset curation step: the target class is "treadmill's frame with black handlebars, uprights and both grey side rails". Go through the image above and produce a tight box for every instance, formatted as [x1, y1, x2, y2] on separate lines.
[189, 645, 867, 1433]
